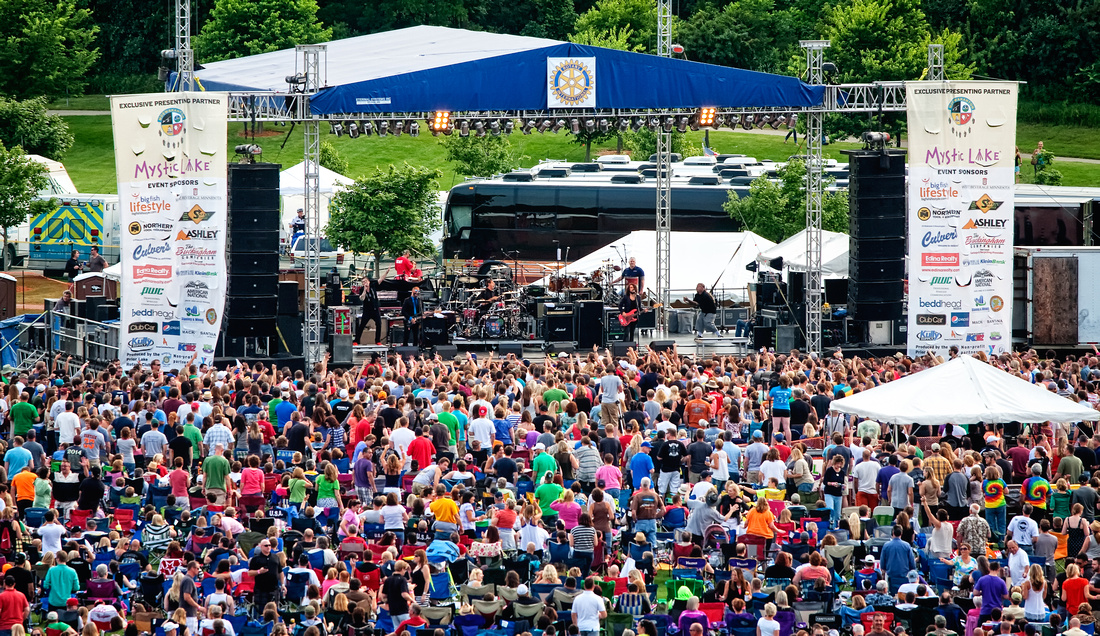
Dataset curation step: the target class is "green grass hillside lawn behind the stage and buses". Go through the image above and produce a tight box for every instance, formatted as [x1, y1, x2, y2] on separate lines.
[65, 113, 1100, 194]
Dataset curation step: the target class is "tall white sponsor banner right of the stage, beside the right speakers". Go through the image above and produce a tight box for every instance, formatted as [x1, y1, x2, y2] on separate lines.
[905, 81, 1019, 355]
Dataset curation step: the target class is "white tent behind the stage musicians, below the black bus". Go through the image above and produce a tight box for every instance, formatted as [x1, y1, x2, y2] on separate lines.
[542, 230, 776, 299]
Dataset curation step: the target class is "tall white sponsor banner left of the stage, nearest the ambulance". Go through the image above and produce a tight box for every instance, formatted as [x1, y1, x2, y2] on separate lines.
[111, 92, 229, 369]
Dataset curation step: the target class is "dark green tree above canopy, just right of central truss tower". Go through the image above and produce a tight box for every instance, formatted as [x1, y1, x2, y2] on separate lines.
[679, 0, 799, 73]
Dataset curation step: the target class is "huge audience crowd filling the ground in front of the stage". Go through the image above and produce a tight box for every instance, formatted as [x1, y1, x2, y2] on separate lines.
[0, 349, 1100, 636]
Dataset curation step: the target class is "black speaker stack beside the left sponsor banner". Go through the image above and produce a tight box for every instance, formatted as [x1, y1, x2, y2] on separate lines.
[221, 163, 279, 358]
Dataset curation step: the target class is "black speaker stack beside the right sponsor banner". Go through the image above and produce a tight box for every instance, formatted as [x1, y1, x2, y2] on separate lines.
[842, 150, 905, 320]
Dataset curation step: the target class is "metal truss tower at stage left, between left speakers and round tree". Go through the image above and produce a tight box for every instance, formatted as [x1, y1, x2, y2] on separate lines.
[297, 44, 325, 368]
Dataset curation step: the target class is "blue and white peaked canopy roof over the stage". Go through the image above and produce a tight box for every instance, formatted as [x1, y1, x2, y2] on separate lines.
[197, 26, 824, 116]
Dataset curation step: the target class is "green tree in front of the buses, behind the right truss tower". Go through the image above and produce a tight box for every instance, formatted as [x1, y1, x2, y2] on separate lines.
[723, 160, 848, 243]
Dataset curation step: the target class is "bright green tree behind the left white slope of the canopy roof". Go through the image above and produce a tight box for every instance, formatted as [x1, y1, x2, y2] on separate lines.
[194, 0, 332, 62]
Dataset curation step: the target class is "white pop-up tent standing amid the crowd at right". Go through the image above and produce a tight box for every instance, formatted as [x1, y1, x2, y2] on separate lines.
[829, 355, 1100, 426]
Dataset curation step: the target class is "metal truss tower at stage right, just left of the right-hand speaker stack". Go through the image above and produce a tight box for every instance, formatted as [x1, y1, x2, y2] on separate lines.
[799, 40, 829, 353]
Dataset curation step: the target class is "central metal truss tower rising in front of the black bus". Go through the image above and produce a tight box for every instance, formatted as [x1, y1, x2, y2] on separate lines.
[639, 0, 672, 332]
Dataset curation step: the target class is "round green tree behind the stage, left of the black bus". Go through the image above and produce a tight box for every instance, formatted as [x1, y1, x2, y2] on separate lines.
[325, 163, 442, 277]
